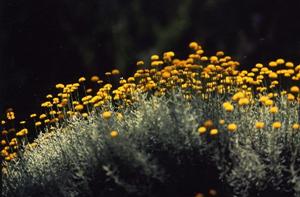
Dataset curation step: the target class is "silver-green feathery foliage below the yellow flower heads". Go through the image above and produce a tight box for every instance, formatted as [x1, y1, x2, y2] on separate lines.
[3, 91, 300, 196]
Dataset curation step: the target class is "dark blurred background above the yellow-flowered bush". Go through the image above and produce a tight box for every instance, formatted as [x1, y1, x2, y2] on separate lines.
[0, 0, 300, 118]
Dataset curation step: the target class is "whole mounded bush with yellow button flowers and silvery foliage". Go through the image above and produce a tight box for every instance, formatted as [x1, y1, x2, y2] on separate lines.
[1, 42, 300, 197]
